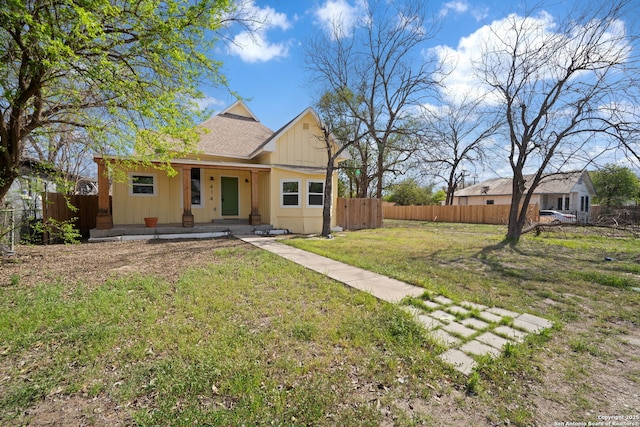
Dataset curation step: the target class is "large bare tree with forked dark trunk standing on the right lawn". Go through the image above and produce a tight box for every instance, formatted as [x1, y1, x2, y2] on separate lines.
[476, 0, 637, 243]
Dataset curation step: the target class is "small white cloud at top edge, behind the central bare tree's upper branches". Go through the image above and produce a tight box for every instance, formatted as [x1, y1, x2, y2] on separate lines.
[314, 0, 366, 38]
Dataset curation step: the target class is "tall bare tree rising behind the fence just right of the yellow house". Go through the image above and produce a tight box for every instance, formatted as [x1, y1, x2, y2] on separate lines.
[306, 0, 437, 197]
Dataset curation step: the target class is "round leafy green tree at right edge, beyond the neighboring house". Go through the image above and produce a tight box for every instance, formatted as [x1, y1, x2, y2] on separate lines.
[591, 164, 640, 206]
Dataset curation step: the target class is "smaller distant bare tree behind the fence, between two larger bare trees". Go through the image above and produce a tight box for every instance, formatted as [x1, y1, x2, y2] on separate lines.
[419, 97, 501, 205]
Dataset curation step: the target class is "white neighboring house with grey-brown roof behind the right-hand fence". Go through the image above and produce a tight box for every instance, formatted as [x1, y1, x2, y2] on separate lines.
[453, 171, 596, 221]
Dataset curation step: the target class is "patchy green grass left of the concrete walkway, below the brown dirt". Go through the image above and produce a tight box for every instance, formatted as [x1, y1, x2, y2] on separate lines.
[0, 242, 448, 425]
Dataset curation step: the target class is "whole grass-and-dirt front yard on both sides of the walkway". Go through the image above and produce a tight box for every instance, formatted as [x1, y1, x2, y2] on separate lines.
[0, 222, 640, 426]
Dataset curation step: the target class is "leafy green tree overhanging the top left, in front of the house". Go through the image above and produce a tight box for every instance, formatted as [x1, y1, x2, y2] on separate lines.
[0, 0, 240, 199]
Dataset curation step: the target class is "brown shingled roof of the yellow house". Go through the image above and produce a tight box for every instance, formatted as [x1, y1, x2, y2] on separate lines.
[198, 101, 274, 158]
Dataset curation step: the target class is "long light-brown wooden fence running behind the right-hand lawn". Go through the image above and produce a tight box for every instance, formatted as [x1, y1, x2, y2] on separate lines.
[383, 204, 539, 224]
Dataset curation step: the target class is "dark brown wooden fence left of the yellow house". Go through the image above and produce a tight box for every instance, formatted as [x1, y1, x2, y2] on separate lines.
[42, 193, 98, 239]
